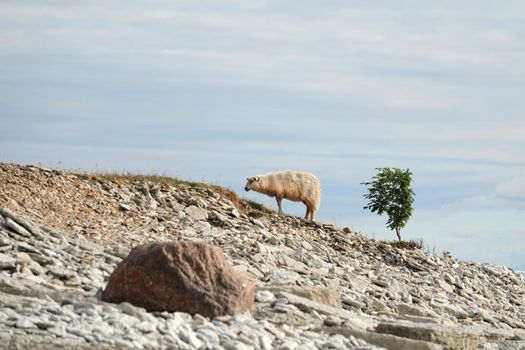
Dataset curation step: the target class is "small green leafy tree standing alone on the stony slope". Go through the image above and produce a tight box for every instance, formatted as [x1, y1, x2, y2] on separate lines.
[361, 168, 415, 241]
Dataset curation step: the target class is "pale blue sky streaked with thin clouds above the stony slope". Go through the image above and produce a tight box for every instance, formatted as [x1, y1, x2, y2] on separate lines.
[0, 0, 525, 270]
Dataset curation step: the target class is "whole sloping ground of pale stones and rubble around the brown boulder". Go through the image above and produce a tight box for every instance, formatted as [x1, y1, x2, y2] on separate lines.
[0, 163, 525, 349]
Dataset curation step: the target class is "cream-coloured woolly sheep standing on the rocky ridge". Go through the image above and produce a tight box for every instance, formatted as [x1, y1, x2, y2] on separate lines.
[244, 171, 321, 221]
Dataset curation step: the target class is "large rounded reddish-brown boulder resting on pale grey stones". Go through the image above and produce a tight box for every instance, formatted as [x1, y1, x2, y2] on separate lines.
[102, 241, 255, 317]
